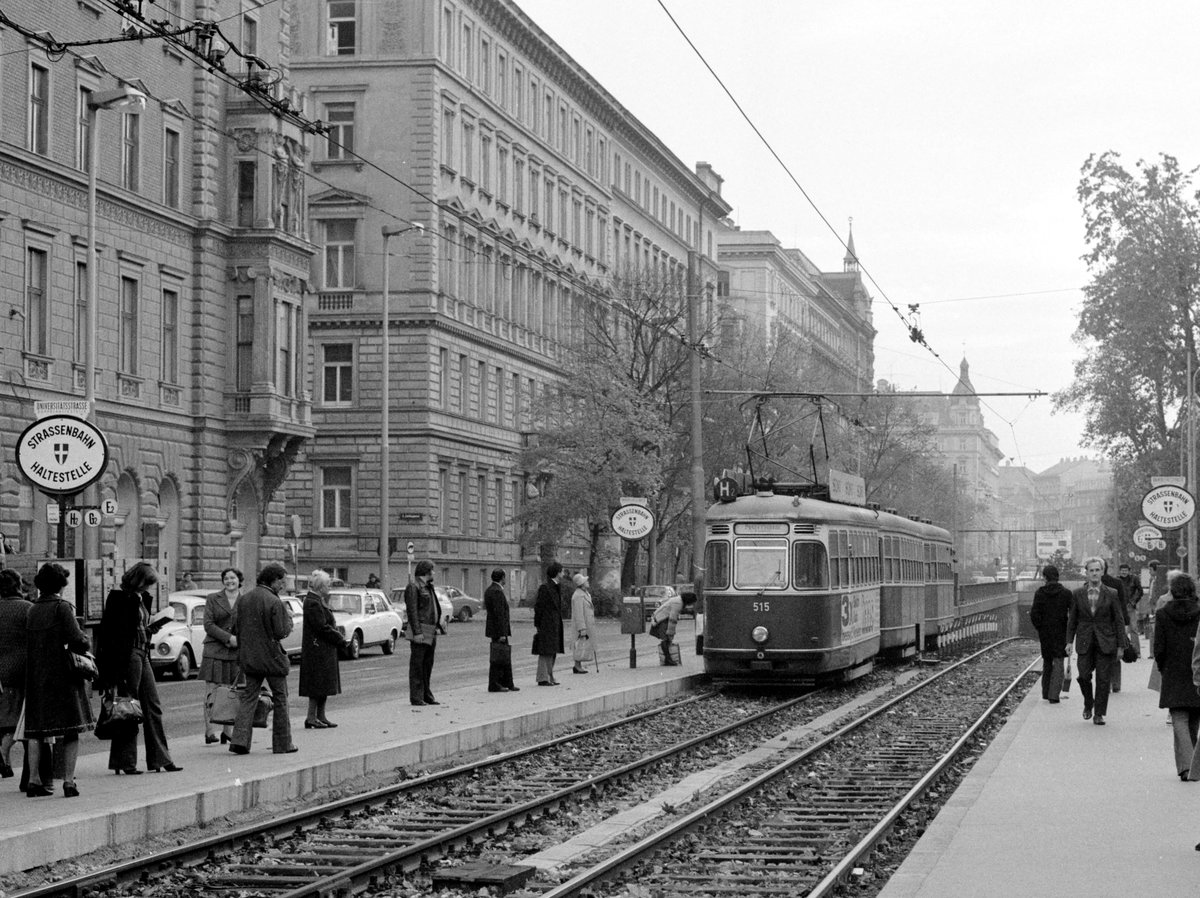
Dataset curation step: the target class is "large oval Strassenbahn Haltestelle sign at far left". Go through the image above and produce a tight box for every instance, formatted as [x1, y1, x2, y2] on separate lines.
[17, 414, 108, 496]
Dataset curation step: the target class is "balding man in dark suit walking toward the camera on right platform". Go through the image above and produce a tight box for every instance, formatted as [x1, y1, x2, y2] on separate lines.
[1067, 558, 1126, 726]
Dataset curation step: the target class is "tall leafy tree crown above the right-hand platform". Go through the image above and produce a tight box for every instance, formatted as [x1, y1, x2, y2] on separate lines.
[1055, 152, 1200, 459]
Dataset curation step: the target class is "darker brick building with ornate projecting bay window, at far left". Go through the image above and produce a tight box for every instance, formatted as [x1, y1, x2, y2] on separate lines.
[0, 0, 313, 615]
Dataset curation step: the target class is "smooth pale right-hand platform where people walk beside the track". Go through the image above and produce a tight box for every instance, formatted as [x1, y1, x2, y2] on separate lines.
[868, 653, 1200, 898]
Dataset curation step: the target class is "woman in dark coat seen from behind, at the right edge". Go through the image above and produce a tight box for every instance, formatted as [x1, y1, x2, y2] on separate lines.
[1154, 574, 1200, 780]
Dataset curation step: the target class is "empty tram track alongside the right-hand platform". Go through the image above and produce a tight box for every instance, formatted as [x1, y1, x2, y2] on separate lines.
[522, 640, 1038, 898]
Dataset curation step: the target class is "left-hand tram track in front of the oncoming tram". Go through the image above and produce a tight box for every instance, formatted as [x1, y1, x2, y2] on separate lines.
[13, 649, 1027, 898]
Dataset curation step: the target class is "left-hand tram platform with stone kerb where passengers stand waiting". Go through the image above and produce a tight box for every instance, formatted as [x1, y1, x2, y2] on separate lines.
[0, 628, 703, 875]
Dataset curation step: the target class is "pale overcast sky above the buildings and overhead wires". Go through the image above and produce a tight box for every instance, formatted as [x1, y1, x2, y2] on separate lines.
[517, 0, 1200, 471]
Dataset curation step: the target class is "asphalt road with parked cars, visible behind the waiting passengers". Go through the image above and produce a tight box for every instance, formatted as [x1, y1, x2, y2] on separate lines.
[80, 609, 676, 760]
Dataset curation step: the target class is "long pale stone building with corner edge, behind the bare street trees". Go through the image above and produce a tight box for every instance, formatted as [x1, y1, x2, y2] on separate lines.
[288, 0, 730, 594]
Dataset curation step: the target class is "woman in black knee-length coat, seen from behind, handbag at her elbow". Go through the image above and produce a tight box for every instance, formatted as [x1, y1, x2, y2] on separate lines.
[24, 563, 92, 798]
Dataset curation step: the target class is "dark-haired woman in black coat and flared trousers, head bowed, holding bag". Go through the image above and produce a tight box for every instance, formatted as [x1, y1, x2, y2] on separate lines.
[100, 562, 182, 776]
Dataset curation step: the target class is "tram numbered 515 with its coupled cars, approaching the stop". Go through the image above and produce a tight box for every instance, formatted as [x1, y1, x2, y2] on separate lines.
[703, 491, 953, 684]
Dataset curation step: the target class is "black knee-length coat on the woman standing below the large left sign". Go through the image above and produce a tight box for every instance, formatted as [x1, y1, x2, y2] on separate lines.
[25, 595, 92, 738]
